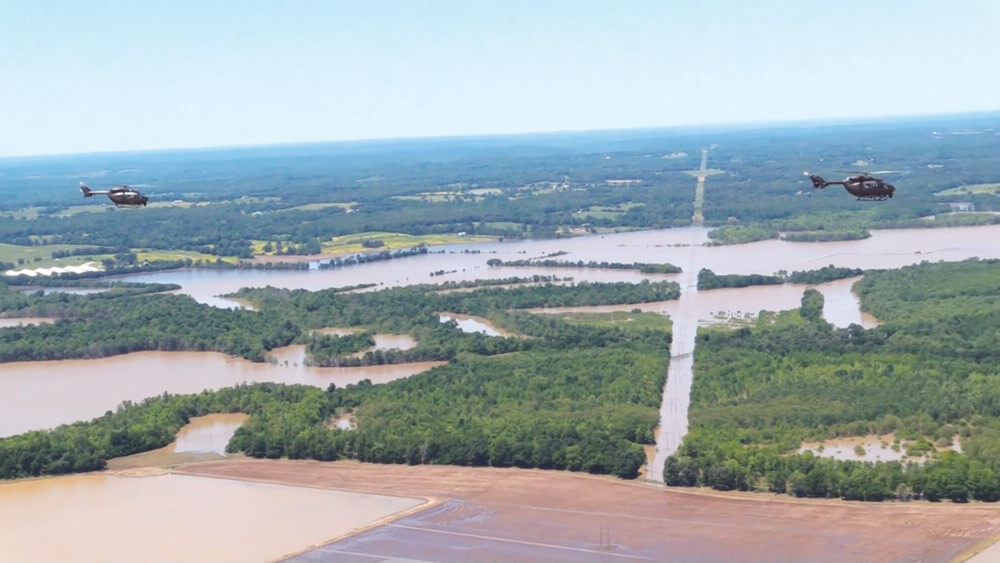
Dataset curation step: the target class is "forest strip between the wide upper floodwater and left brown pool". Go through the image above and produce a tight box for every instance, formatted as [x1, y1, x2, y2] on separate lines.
[0, 281, 680, 365]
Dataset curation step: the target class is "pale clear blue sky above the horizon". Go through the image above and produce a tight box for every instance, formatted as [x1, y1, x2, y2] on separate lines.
[0, 0, 1000, 156]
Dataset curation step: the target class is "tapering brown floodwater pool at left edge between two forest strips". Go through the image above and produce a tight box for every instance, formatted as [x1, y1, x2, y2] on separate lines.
[0, 351, 441, 437]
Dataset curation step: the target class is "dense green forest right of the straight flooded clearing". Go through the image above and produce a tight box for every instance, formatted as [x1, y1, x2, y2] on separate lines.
[664, 260, 1000, 502]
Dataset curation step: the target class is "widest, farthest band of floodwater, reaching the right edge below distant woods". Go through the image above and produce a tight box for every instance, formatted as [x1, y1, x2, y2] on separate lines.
[113, 225, 1000, 307]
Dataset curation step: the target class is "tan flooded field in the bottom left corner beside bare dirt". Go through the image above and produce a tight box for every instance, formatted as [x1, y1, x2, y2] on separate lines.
[0, 473, 425, 562]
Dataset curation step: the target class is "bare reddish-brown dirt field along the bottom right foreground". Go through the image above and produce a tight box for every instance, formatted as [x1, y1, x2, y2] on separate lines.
[175, 459, 1000, 561]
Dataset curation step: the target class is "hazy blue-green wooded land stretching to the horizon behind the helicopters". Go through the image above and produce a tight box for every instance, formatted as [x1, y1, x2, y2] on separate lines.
[0, 115, 1000, 259]
